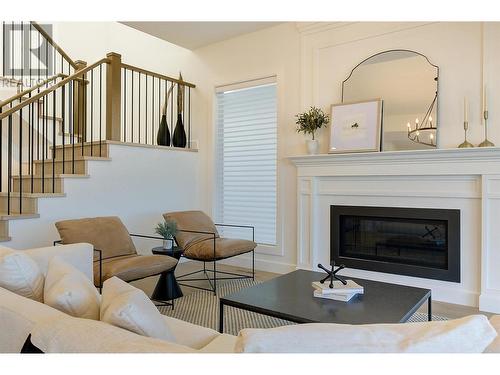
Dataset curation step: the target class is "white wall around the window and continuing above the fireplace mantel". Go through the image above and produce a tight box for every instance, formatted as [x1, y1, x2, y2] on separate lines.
[195, 22, 500, 271]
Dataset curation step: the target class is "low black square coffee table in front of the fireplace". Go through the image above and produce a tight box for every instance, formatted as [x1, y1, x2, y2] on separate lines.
[219, 270, 432, 332]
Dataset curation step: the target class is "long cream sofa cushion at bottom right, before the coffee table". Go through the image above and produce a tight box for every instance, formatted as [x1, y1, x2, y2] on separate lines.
[236, 315, 497, 353]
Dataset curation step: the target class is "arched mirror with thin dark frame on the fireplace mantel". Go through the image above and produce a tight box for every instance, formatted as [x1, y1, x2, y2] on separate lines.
[342, 50, 439, 151]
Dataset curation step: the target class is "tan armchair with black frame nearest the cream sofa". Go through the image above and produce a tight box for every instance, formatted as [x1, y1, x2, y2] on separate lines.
[55, 216, 177, 288]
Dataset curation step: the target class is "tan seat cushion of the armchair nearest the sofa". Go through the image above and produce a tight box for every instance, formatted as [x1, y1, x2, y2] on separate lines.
[94, 254, 177, 285]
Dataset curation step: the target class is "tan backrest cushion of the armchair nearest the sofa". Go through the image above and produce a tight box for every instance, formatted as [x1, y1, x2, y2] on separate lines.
[55, 216, 136, 259]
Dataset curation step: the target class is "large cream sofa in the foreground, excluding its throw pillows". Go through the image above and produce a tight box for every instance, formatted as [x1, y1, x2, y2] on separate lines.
[0, 244, 500, 353]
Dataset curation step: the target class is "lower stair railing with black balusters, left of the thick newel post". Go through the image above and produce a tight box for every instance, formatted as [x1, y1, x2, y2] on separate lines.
[0, 58, 109, 215]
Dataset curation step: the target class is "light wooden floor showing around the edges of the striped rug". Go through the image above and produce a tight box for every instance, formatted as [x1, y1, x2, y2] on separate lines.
[133, 262, 493, 319]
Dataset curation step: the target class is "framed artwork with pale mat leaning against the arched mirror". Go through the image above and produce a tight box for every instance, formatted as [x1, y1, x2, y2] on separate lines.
[329, 99, 383, 153]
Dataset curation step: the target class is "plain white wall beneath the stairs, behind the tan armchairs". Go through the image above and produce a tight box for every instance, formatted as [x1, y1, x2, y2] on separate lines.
[5, 145, 199, 252]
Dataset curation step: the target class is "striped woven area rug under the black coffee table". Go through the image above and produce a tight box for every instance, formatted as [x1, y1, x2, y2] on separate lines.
[159, 279, 448, 335]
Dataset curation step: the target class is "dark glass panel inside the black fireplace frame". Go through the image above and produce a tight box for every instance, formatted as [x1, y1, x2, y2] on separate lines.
[339, 215, 448, 270]
